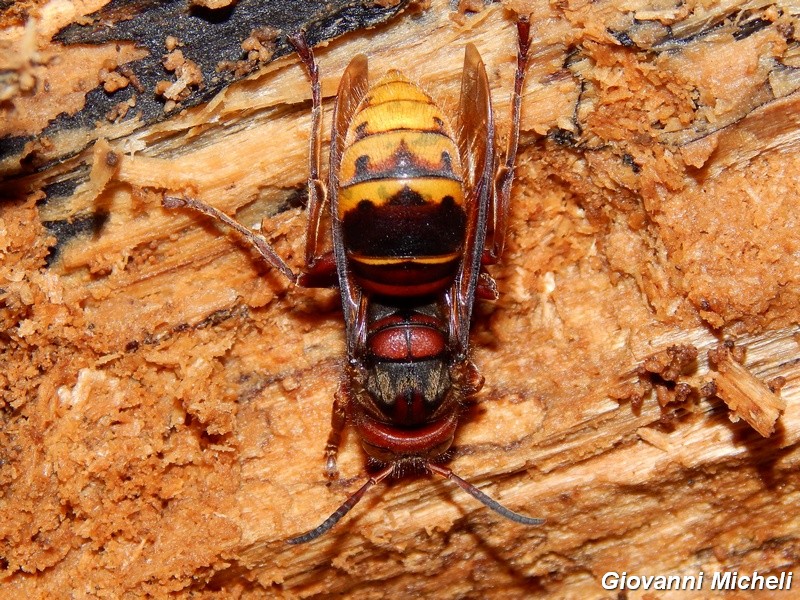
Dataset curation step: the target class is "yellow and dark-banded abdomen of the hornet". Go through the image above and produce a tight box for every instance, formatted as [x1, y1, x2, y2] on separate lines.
[338, 71, 466, 296]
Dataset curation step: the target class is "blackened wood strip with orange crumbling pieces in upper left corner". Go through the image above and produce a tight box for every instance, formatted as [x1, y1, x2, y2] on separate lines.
[0, 0, 408, 174]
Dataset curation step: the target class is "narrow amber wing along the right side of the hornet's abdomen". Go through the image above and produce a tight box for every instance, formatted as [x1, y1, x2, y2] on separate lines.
[451, 44, 495, 357]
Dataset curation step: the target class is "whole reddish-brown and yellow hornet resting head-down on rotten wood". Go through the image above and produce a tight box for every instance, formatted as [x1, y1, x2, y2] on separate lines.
[163, 18, 543, 544]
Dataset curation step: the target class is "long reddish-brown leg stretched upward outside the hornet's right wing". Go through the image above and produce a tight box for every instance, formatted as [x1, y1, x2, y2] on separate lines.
[483, 17, 531, 264]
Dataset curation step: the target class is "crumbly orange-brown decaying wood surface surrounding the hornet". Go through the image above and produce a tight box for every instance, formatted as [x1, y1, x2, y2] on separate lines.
[0, 0, 800, 598]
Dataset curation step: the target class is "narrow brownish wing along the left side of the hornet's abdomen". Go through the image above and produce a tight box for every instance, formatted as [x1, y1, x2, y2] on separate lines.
[328, 54, 369, 358]
